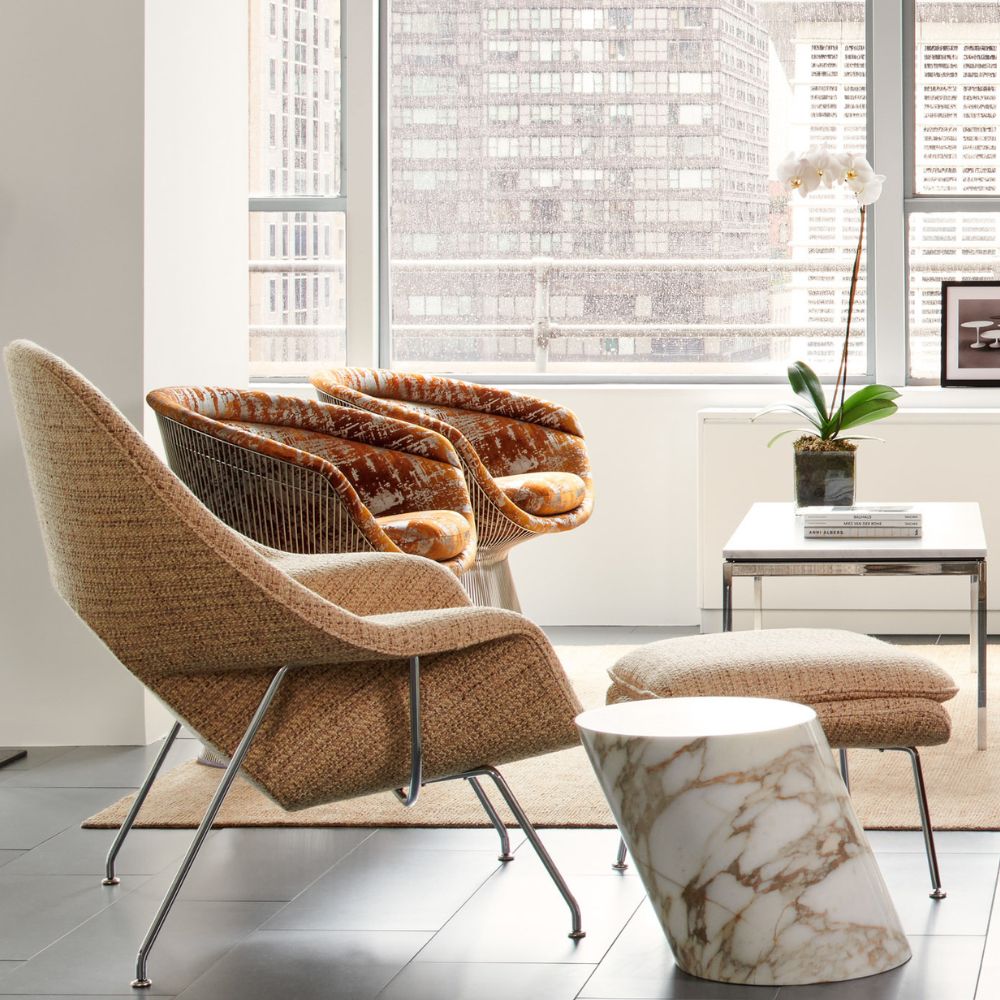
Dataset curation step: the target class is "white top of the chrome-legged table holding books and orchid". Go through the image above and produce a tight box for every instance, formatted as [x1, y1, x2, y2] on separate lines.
[722, 501, 986, 561]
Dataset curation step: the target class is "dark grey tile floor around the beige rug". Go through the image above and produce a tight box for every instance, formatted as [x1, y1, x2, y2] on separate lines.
[0, 629, 1000, 1000]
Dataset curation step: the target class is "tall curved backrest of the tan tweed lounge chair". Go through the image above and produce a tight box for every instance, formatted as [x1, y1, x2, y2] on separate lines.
[5, 341, 394, 683]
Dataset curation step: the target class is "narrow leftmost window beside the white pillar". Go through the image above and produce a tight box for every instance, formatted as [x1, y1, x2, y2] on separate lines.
[249, 0, 346, 379]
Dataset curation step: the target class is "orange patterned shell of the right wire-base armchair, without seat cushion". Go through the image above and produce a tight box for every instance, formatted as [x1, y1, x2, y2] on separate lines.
[311, 368, 593, 558]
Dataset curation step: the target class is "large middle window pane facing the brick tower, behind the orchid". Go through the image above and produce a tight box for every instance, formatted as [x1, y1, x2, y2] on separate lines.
[386, 0, 872, 377]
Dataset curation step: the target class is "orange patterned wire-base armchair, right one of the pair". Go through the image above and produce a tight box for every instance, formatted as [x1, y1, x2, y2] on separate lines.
[312, 368, 594, 611]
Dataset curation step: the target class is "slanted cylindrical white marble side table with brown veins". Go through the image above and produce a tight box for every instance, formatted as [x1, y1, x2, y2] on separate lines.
[576, 698, 910, 986]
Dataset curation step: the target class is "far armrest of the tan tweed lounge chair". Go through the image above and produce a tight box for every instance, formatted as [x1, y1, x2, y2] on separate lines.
[254, 543, 471, 617]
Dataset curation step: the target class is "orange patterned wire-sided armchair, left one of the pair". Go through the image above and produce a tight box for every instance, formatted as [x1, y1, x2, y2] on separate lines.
[146, 386, 476, 573]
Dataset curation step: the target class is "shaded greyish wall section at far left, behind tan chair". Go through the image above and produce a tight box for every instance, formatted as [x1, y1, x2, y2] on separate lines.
[0, 0, 145, 744]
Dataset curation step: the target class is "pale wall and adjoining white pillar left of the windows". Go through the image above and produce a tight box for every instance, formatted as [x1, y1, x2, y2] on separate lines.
[0, 0, 248, 745]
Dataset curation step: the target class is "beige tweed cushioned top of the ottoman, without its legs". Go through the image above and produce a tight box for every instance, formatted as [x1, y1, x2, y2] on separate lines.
[607, 628, 958, 747]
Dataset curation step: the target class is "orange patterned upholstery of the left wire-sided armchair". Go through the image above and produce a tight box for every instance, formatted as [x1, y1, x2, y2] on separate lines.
[147, 387, 476, 572]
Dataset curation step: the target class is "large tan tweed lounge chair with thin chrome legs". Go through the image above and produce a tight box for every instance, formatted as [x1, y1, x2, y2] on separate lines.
[5, 341, 583, 987]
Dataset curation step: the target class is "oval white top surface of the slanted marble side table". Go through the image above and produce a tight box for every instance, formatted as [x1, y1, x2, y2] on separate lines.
[576, 697, 816, 740]
